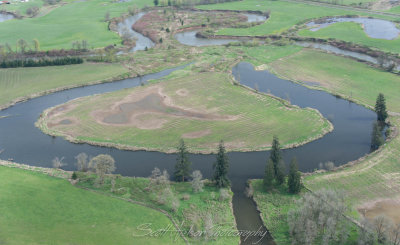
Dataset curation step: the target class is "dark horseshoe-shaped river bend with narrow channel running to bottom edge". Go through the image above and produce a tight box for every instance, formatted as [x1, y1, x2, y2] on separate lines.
[0, 62, 375, 244]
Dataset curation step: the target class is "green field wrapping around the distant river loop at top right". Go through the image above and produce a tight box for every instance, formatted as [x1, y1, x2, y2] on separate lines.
[199, 0, 390, 36]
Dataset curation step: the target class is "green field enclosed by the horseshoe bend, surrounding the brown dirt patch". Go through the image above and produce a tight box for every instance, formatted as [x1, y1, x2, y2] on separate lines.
[39, 66, 331, 152]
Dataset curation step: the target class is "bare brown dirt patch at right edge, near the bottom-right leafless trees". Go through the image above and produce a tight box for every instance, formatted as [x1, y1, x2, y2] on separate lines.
[358, 198, 400, 224]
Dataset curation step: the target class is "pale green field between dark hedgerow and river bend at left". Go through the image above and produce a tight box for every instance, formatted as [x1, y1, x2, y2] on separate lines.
[0, 63, 128, 106]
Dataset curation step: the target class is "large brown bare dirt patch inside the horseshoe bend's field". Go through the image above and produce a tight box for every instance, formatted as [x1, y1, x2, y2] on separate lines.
[92, 86, 237, 129]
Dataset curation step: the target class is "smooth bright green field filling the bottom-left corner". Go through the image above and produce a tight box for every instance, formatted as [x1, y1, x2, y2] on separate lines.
[0, 166, 184, 245]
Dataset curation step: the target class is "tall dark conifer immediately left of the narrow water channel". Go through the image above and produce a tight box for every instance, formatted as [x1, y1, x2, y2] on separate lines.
[214, 140, 230, 188]
